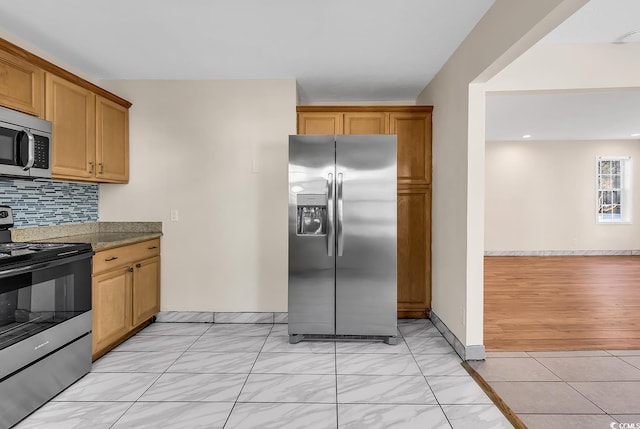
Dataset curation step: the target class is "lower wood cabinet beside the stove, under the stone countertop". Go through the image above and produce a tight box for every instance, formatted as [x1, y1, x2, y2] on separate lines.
[92, 239, 160, 360]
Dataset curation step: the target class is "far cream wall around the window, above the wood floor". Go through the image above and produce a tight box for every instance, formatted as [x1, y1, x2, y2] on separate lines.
[485, 140, 640, 251]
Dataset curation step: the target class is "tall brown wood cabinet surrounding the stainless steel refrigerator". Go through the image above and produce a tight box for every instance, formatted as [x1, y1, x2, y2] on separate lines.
[297, 106, 433, 318]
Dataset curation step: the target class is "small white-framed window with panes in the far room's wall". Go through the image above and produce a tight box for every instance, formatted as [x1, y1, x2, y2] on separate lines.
[596, 156, 631, 223]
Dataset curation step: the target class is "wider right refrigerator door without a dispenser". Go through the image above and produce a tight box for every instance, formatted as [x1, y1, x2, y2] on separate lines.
[336, 135, 397, 336]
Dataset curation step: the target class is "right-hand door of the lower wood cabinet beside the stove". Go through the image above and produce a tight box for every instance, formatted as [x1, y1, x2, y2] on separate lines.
[133, 256, 160, 327]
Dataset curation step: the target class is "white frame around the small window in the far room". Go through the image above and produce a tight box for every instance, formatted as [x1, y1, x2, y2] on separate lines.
[595, 156, 633, 225]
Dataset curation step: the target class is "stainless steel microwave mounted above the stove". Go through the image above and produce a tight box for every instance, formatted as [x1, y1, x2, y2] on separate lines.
[0, 107, 52, 179]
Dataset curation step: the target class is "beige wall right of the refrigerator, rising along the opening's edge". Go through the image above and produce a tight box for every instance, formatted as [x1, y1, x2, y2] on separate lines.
[416, 0, 586, 346]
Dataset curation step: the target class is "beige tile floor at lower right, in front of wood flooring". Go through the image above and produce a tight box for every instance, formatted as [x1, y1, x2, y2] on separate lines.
[470, 350, 640, 429]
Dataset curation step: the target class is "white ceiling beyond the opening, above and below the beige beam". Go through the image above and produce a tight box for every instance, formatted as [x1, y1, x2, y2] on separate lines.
[486, 0, 640, 141]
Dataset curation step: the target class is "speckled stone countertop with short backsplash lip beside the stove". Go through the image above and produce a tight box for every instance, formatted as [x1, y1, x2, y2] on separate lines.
[11, 222, 162, 252]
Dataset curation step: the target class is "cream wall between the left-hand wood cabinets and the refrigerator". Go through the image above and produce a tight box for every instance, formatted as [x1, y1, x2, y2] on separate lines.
[100, 80, 296, 311]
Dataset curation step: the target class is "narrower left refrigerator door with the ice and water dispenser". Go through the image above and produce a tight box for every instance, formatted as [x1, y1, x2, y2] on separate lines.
[289, 135, 335, 335]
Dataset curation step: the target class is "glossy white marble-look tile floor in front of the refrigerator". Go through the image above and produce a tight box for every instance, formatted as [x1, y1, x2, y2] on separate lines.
[17, 320, 512, 429]
